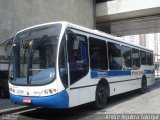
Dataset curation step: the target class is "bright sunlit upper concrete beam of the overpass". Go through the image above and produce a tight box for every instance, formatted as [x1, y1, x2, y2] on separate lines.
[96, 0, 160, 23]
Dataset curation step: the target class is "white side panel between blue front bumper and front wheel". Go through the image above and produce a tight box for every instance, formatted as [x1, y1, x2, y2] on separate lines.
[69, 74, 99, 107]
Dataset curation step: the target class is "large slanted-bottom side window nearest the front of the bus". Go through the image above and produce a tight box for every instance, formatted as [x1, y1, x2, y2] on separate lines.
[67, 34, 89, 84]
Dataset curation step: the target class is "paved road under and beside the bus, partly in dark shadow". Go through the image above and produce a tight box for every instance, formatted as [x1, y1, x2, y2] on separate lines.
[2, 80, 160, 120]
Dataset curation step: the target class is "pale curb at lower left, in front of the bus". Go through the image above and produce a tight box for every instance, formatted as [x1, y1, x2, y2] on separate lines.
[0, 106, 30, 115]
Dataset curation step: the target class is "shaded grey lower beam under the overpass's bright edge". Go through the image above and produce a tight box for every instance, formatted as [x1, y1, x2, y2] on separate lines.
[97, 15, 160, 36]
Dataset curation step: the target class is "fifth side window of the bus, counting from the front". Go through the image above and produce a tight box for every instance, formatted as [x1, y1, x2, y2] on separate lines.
[132, 48, 140, 69]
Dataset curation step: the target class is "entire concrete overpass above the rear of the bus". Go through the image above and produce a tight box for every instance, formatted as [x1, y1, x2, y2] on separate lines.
[96, 0, 160, 36]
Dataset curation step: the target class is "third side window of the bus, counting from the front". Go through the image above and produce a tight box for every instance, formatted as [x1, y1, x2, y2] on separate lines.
[108, 42, 122, 70]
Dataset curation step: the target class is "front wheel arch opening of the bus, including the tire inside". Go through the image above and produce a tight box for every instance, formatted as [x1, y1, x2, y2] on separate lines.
[94, 79, 110, 109]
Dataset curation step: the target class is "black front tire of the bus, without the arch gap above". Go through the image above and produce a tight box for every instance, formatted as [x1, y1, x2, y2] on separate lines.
[94, 84, 107, 109]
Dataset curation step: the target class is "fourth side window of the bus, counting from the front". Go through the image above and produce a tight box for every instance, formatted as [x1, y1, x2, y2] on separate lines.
[121, 46, 132, 69]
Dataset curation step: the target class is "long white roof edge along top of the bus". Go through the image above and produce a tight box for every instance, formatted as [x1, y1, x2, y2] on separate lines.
[17, 21, 153, 51]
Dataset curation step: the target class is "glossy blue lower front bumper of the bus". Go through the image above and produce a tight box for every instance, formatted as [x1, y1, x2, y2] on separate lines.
[10, 90, 69, 108]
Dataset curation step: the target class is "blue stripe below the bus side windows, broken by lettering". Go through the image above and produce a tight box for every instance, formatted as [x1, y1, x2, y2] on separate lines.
[91, 70, 154, 78]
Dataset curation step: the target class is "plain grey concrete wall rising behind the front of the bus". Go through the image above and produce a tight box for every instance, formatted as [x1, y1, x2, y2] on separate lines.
[0, 0, 94, 43]
